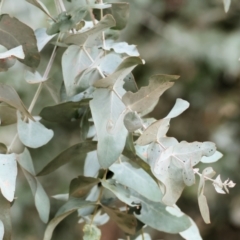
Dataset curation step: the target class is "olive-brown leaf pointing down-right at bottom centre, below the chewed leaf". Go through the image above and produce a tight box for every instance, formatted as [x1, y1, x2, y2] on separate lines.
[102, 206, 137, 234]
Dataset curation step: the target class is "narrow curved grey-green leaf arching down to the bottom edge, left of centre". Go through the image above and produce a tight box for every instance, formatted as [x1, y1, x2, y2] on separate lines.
[43, 198, 94, 240]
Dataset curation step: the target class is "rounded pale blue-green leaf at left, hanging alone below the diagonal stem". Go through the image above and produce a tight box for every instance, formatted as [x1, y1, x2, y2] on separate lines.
[17, 112, 54, 148]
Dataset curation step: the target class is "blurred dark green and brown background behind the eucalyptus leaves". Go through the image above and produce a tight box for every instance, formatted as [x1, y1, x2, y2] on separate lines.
[0, 0, 240, 240]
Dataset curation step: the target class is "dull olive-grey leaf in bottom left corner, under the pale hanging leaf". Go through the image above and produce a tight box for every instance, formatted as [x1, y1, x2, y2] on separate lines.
[0, 193, 12, 240]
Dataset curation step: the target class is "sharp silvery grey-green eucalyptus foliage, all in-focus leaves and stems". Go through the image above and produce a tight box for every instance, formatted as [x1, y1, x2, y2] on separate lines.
[0, 0, 234, 240]
